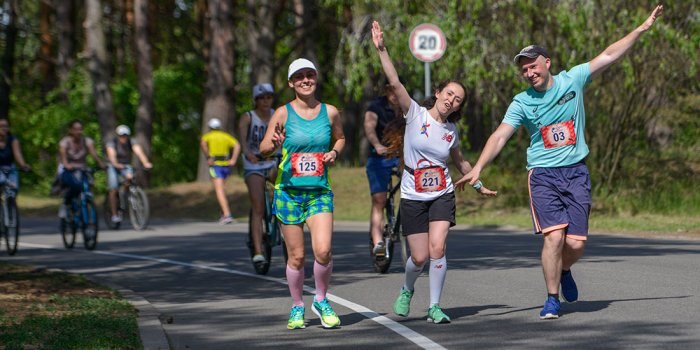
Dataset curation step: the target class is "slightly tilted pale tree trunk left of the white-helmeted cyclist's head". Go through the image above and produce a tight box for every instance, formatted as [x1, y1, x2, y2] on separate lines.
[85, 0, 116, 143]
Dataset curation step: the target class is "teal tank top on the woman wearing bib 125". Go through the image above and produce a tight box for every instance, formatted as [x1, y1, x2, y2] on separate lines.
[275, 103, 331, 191]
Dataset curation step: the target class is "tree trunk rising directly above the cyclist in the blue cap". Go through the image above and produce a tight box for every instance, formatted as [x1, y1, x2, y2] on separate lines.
[247, 0, 279, 88]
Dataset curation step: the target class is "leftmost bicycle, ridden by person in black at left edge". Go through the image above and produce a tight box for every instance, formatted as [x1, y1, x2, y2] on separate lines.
[0, 165, 26, 255]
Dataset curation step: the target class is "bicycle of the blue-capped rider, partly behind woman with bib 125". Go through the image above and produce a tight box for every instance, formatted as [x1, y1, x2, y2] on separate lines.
[246, 155, 288, 275]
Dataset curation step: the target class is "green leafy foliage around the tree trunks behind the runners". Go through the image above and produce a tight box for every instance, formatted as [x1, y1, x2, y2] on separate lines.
[0, 0, 700, 216]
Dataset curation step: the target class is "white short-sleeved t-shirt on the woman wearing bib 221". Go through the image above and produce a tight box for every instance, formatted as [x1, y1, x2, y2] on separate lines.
[401, 100, 459, 201]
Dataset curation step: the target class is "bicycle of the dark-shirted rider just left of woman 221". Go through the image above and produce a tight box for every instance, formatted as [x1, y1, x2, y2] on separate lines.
[369, 167, 409, 273]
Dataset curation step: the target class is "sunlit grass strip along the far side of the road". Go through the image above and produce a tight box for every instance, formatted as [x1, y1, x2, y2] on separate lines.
[19, 166, 700, 235]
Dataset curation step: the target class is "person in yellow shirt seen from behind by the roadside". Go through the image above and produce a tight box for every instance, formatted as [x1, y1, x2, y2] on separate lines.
[199, 118, 241, 225]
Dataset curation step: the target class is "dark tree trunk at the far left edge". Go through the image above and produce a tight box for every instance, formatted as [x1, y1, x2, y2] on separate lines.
[0, 0, 19, 120]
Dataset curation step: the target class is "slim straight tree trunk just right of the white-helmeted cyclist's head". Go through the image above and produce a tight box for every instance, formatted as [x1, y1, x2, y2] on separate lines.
[134, 0, 154, 185]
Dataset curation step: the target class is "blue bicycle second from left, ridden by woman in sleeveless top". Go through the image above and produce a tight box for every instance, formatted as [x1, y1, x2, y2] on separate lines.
[59, 168, 99, 250]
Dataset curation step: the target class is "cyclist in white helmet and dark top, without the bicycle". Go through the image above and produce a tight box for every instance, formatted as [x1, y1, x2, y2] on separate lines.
[106, 125, 153, 223]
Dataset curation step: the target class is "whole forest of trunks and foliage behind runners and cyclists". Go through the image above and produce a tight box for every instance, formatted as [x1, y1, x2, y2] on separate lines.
[0, 0, 700, 221]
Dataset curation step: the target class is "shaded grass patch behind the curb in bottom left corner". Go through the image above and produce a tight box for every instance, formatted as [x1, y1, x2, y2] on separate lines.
[0, 263, 143, 350]
